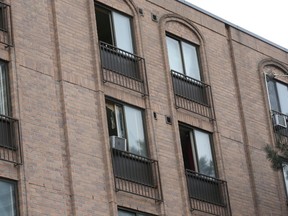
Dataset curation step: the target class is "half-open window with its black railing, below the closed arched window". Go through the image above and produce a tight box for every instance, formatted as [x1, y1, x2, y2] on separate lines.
[179, 124, 230, 215]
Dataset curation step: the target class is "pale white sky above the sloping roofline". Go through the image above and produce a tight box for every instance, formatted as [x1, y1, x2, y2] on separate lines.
[186, 0, 288, 49]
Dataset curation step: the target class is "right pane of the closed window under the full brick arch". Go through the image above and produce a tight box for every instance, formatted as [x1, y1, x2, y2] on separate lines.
[182, 42, 201, 80]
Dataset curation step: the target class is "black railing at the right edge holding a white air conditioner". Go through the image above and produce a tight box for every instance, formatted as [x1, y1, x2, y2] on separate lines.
[272, 110, 288, 146]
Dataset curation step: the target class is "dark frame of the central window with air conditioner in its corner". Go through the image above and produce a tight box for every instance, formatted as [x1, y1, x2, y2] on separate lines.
[105, 97, 150, 158]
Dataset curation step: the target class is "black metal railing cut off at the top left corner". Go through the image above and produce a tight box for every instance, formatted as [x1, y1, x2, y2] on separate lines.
[0, 1, 13, 47]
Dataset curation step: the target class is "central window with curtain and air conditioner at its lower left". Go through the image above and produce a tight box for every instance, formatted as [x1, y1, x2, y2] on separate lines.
[106, 101, 147, 157]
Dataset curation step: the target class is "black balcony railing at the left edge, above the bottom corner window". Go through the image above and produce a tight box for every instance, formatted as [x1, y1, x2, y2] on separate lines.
[0, 115, 22, 165]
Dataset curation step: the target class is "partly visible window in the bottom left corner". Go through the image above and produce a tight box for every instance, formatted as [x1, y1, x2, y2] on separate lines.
[0, 179, 18, 216]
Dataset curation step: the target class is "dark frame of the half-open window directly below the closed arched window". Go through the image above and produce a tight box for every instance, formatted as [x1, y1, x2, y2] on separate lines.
[179, 122, 218, 178]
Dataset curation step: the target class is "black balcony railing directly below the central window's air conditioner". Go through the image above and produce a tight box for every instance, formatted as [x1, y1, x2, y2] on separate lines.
[111, 148, 162, 201]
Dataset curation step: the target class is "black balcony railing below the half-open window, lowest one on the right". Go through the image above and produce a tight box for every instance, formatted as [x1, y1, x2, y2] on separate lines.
[186, 170, 231, 216]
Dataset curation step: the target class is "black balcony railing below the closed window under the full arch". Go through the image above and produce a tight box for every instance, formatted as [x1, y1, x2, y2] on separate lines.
[171, 70, 214, 119]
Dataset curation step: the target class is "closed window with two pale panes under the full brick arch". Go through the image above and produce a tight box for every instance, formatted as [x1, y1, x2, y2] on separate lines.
[166, 36, 201, 80]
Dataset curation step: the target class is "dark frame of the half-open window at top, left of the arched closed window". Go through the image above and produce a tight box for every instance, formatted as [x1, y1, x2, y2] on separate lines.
[94, 2, 136, 54]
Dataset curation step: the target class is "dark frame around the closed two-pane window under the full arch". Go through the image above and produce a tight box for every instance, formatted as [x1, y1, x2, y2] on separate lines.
[165, 32, 203, 82]
